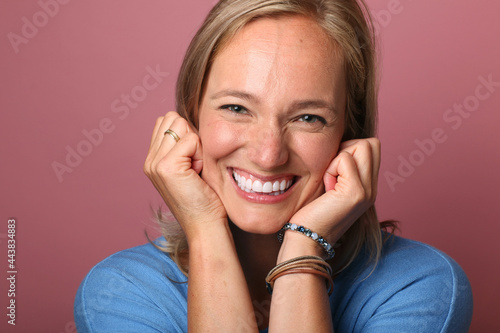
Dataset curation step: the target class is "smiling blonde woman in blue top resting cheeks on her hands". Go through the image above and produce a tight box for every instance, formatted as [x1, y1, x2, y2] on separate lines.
[75, 0, 472, 332]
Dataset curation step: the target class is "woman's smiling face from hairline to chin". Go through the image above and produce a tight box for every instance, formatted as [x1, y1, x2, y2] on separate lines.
[199, 17, 346, 234]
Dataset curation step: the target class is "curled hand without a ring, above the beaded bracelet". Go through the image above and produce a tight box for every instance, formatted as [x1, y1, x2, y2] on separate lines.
[288, 138, 381, 252]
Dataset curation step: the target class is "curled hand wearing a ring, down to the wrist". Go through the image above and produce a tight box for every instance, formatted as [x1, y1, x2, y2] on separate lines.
[144, 111, 227, 239]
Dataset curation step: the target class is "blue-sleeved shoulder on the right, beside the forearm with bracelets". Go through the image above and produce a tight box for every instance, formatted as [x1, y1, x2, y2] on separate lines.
[334, 236, 472, 332]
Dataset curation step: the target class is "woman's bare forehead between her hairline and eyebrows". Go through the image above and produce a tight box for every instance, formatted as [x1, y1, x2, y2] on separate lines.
[207, 16, 344, 104]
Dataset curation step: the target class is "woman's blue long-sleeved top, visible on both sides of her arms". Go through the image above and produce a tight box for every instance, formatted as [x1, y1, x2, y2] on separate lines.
[75, 237, 472, 333]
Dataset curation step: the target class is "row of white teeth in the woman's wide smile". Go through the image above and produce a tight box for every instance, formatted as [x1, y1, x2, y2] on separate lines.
[232, 170, 294, 195]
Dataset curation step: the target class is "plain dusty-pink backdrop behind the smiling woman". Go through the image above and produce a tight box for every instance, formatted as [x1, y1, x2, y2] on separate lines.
[0, 0, 500, 333]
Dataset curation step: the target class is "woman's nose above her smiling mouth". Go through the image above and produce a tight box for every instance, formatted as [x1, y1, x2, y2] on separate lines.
[248, 125, 288, 170]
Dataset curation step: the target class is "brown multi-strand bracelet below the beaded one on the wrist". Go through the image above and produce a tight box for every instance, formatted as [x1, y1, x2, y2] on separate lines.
[266, 256, 333, 295]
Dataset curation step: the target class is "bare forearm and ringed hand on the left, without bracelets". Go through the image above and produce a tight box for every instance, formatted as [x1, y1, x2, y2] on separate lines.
[144, 112, 257, 332]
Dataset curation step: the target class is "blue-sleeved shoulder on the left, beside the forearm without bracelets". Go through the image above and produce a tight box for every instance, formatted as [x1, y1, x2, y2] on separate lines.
[74, 239, 187, 332]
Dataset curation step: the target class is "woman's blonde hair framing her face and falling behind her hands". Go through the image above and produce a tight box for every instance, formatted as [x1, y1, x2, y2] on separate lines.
[157, 0, 394, 273]
